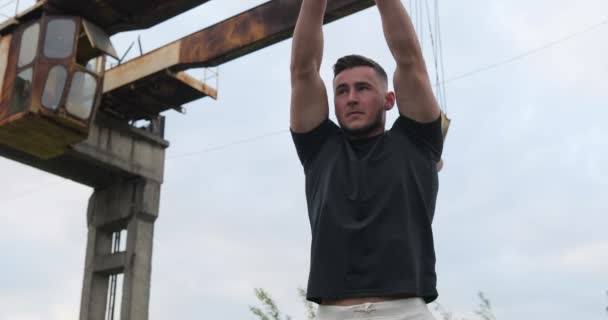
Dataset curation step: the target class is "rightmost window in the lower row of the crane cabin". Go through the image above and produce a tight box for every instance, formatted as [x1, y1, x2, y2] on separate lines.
[65, 71, 97, 120]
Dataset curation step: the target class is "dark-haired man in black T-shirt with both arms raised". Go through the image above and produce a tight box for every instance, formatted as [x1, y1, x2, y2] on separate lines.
[290, 0, 443, 320]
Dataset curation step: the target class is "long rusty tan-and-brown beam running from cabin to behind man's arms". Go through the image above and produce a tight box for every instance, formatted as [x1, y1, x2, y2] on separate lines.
[104, 0, 375, 92]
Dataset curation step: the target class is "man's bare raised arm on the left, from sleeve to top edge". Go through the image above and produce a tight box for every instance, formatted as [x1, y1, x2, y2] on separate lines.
[290, 0, 329, 133]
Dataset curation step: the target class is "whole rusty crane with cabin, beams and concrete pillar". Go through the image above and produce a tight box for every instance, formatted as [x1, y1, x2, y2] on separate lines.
[0, 0, 374, 320]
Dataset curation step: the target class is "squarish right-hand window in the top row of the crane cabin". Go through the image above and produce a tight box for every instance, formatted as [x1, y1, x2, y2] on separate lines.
[44, 19, 76, 59]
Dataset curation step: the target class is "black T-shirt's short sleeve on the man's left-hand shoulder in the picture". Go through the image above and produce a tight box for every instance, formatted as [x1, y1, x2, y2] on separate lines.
[291, 119, 340, 170]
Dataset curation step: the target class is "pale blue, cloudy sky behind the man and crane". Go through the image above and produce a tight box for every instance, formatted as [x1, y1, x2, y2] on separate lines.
[0, 0, 608, 320]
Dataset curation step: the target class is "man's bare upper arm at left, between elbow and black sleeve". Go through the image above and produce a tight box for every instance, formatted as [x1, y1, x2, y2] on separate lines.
[290, 71, 329, 133]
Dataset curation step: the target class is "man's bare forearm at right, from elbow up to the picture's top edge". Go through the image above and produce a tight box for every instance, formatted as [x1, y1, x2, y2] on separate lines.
[376, 0, 424, 67]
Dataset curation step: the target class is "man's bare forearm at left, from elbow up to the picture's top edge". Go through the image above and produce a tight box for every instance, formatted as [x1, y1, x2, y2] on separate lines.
[291, 0, 327, 76]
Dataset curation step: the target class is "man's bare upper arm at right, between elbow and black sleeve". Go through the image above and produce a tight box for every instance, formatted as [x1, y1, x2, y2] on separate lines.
[393, 61, 440, 123]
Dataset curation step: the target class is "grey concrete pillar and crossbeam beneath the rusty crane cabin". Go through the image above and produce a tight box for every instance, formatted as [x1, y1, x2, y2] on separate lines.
[0, 112, 169, 320]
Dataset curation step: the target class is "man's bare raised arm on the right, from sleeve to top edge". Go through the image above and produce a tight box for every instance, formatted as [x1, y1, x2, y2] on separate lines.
[376, 0, 440, 122]
